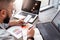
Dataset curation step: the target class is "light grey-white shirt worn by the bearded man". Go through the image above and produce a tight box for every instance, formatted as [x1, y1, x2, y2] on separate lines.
[0, 23, 15, 40]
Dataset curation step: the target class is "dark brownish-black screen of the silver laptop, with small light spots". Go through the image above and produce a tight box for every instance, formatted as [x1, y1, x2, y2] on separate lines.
[22, 0, 41, 14]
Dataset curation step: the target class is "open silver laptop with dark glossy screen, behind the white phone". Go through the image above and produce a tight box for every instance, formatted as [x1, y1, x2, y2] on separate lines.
[13, 0, 41, 23]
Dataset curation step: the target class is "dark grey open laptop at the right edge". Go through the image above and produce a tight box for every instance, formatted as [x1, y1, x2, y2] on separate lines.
[36, 11, 60, 40]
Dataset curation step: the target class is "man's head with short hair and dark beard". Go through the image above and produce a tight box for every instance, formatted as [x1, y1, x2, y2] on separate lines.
[0, 0, 14, 22]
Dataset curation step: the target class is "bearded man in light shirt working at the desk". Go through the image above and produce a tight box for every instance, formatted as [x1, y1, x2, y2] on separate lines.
[0, 0, 34, 40]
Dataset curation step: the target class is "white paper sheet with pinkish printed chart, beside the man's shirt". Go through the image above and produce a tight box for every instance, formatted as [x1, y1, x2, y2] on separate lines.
[7, 26, 22, 39]
